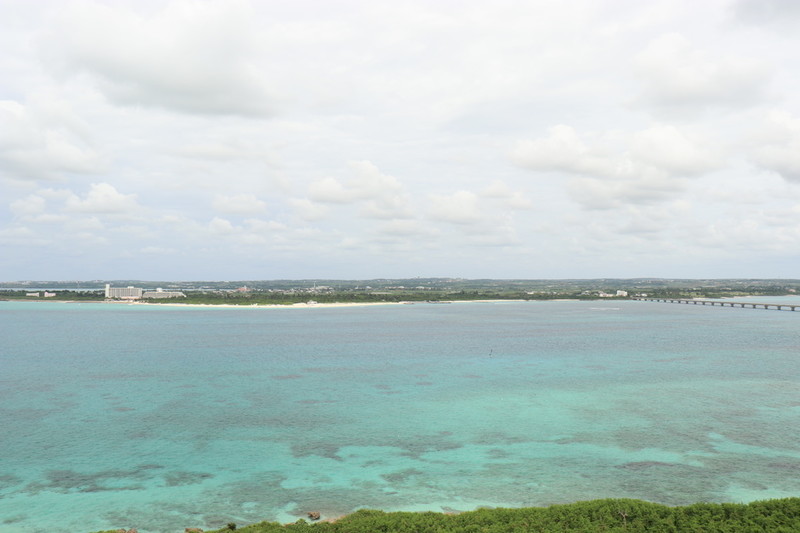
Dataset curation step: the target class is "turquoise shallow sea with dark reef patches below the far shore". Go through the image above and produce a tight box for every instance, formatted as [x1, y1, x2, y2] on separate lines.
[0, 299, 800, 533]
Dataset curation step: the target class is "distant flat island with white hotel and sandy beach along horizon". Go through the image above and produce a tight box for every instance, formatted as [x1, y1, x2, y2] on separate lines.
[0, 278, 800, 305]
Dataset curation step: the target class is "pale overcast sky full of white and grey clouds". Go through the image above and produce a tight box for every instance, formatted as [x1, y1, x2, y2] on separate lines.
[0, 0, 800, 281]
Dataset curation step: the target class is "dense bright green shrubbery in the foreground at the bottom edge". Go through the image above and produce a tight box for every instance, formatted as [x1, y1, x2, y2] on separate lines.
[90, 498, 800, 533]
